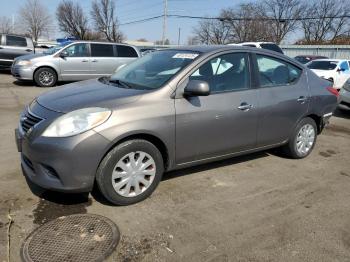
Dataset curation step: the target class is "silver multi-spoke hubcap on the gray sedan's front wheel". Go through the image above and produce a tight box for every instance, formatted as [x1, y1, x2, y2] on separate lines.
[112, 151, 156, 197]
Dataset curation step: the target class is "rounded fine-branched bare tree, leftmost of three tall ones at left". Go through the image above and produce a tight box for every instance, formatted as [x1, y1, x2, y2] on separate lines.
[20, 0, 51, 41]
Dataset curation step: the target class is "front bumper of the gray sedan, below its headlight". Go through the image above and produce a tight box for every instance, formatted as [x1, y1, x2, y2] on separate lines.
[15, 102, 110, 193]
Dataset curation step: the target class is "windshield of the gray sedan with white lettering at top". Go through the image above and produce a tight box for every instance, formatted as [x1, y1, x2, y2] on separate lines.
[110, 50, 199, 89]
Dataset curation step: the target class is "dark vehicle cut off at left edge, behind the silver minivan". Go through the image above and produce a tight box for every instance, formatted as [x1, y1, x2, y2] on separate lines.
[0, 33, 34, 69]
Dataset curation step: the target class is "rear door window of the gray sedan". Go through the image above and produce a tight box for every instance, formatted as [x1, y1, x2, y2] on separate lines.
[256, 55, 302, 87]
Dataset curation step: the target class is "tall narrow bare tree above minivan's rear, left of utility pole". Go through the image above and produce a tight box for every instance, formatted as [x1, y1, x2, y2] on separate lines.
[91, 0, 124, 42]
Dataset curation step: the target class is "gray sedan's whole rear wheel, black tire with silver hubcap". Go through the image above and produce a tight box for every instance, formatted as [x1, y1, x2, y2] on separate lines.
[282, 117, 317, 159]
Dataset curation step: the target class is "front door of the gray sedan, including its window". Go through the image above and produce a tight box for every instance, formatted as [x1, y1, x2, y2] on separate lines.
[175, 53, 257, 164]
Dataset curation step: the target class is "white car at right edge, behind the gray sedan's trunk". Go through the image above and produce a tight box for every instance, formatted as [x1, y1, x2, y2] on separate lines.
[306, 59, 350, 89]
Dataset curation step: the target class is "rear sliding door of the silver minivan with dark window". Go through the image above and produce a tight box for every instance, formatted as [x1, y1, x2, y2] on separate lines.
[90, 44, 119, 77]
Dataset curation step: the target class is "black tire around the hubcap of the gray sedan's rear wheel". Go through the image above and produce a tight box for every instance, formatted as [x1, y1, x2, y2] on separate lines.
[282, 117, 317, 159]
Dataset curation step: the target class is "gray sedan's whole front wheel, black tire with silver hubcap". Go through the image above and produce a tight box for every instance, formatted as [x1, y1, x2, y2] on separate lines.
[96, 139, 164, 205]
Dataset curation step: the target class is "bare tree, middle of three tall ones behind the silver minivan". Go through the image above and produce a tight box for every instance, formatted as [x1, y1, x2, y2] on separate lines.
[56, 0, 89, 40]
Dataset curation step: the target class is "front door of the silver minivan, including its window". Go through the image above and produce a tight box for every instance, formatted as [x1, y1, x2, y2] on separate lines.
[56, 43, 90, 81]
